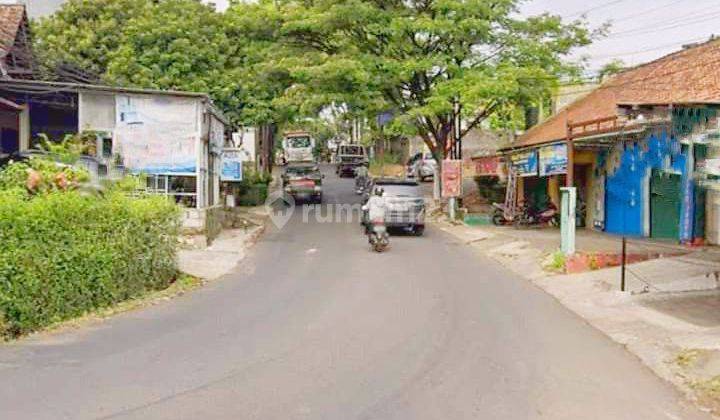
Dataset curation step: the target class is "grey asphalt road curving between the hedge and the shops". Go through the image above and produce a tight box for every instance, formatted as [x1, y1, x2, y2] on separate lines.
[0, 166, 706, 420]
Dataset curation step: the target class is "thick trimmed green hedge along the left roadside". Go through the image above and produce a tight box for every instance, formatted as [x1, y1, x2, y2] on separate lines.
[0, 191, 179, 336]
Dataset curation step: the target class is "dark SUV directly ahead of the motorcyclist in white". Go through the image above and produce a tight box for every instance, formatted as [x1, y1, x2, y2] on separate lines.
[362, 178, 425, 236]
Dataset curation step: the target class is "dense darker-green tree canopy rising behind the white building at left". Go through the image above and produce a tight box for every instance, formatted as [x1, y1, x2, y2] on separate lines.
[33, 0, 287, 123]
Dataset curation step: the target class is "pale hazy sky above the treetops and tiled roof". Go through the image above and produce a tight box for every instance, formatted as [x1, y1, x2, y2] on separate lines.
[19, 0, 720, 74]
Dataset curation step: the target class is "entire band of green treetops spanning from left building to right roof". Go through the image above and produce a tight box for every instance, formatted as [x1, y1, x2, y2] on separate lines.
[34, 0, 592, 146]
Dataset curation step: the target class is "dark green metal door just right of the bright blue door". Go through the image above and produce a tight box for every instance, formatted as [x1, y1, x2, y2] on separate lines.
[650, 171, 682, 239]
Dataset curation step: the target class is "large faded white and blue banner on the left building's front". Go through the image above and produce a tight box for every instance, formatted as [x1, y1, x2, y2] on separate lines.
[113, 95, 198, 175]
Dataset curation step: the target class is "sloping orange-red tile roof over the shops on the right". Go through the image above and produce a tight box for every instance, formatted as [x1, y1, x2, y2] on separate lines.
[512, 39, 720, 147]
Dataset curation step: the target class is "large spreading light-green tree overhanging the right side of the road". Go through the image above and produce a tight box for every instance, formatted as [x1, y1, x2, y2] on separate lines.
[279, 0, 593, 160]
